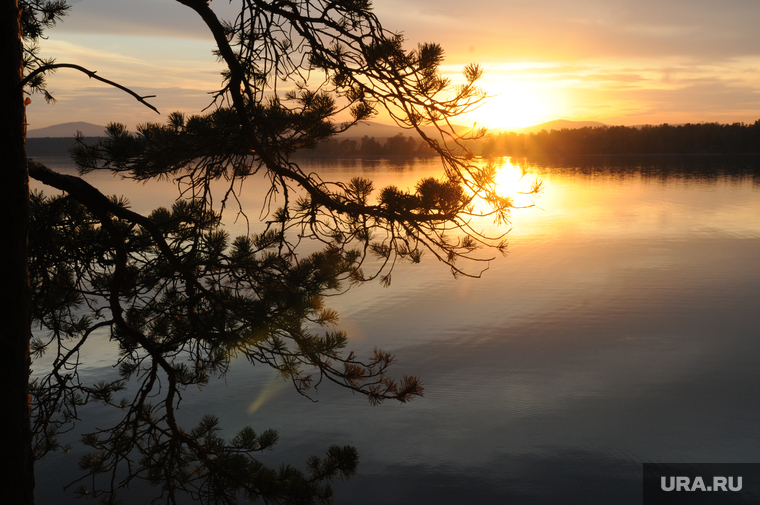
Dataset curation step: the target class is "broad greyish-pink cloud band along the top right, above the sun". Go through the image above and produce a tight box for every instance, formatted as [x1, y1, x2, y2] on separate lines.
[377, 0, 760, 61]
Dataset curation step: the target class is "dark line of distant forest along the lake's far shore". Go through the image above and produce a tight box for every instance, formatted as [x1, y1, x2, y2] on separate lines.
[299, 120, 760, 157]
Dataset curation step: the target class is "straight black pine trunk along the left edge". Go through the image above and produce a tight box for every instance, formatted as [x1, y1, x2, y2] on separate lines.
[0, 0, 34, 505]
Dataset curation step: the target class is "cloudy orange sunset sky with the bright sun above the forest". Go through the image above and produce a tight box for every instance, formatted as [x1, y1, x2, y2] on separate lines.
[27, 0, 760, 129]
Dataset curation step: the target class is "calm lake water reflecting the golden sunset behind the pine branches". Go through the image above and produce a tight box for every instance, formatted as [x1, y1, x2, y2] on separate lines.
[33, 156, 760, 505]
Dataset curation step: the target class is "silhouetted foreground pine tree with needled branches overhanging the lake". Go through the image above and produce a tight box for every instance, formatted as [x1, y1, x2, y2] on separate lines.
[5, 0, 540, 503]
